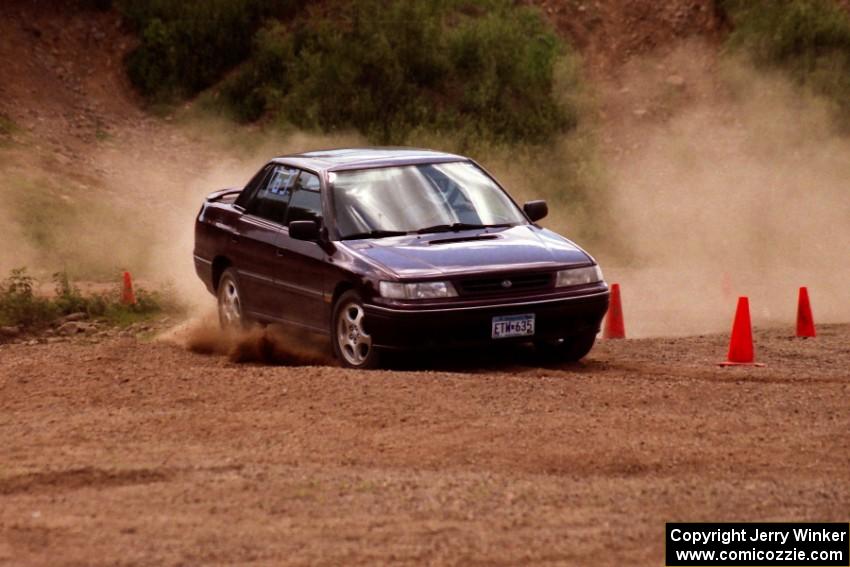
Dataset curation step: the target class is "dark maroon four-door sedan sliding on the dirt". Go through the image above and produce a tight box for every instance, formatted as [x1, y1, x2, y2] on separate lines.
[195, 148, 608, 368]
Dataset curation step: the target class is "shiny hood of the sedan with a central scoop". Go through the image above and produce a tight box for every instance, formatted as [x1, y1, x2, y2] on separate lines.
[345, 225, 592, 278]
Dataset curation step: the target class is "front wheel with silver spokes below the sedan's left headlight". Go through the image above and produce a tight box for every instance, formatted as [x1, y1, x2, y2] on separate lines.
[331, 291, 379, 368]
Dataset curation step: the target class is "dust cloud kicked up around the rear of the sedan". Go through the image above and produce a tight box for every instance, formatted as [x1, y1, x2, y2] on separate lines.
[102, 125, 354, 366]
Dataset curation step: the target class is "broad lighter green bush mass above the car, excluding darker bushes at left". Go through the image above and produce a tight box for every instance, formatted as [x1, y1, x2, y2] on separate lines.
[223, 0, 576, 143]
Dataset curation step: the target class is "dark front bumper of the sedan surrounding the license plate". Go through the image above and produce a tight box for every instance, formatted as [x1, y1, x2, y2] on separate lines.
[365, 289, 609, 349]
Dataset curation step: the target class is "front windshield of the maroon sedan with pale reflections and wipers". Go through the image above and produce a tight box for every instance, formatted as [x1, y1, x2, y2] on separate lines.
[332, 162, 526, 239]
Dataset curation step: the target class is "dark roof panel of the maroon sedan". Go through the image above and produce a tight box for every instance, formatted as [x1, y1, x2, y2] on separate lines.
[272, 148, 468, 171]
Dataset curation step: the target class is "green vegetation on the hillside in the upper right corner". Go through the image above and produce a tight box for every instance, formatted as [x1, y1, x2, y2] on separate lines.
[723, 0, 850, 127]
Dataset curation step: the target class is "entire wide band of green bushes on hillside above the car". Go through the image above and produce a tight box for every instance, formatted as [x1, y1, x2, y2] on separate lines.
[118, 0, 577, 143]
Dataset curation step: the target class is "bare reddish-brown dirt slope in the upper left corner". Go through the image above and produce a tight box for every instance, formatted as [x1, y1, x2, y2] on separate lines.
[0, 0, 142, 159]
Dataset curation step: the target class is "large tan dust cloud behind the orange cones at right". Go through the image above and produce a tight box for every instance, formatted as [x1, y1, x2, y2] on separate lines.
[601, 46, 850, 336]
